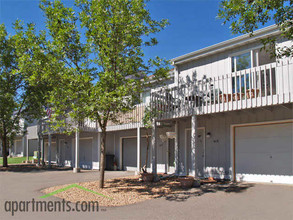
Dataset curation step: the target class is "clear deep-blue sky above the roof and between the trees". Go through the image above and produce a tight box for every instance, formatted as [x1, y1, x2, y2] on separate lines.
[0, 0, 266, 62]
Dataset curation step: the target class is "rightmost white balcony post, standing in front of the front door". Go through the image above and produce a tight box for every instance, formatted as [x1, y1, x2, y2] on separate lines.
[191, 115, 198, 178]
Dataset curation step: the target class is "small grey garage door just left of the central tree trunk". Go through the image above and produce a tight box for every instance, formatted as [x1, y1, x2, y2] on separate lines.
[79, 139, 92, 169]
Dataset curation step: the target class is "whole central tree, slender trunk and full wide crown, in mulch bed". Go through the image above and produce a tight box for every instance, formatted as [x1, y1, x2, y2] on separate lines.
[41, 0, 169, 188]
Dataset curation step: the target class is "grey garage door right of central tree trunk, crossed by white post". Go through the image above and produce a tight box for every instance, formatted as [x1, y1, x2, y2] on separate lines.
[122, 137, 150, 171]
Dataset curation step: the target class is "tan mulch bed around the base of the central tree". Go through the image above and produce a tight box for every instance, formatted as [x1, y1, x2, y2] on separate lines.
[42, 176, 248, 206]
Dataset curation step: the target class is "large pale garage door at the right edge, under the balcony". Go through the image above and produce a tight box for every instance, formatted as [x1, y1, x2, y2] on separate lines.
[235, 123, 293, 184]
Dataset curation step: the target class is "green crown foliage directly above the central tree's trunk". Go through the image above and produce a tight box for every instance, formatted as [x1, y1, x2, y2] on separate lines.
[77, 0, 168, 128]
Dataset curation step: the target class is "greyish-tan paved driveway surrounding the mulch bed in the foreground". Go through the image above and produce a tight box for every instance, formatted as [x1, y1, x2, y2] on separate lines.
[0, 170, 293, 219]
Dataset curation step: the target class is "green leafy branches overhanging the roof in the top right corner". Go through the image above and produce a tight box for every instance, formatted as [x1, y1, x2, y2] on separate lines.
[218, 0, 293, 57]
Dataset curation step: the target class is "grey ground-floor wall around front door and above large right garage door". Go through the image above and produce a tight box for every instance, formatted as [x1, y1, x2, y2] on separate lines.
[179, 106, 293, 178]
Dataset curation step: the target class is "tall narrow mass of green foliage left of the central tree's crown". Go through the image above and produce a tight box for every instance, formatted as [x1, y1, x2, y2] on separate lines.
[40, 1, 96, 133]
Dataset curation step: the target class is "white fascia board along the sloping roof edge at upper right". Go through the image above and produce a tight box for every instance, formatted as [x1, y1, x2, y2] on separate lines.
[171, 25, 281, 65]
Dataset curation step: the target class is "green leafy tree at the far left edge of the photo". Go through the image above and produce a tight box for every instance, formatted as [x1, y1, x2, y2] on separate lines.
[0, 21, 49, 167]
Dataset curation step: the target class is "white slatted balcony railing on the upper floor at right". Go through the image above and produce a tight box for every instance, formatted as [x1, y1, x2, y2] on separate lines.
[151, 59, 293, 119]
